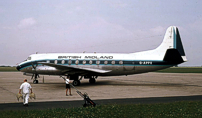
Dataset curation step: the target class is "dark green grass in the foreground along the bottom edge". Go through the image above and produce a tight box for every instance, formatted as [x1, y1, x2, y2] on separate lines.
[0, 101, 202, 118]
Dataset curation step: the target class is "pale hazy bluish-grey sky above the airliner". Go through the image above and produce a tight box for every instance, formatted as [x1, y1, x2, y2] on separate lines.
[0, 0, 202, 66]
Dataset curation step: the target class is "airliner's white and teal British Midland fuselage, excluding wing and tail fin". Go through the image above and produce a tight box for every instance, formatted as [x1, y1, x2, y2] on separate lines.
[16, 53, 174, 76]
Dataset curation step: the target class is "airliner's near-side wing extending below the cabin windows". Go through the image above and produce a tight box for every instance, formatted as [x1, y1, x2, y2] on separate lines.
[38, 62, 111, 74]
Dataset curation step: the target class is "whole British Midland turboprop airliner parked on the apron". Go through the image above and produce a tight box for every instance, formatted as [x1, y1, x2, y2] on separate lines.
[16, 26, 187, 86]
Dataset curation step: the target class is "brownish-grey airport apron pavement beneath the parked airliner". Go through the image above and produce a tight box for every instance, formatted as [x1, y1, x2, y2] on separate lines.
[0, 72, 202, 108]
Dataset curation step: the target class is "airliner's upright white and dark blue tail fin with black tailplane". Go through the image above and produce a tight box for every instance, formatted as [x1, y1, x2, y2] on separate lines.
[159, 26, 187, 64]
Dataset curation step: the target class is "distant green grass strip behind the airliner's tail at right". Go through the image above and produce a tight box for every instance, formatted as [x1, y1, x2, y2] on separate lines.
[156, 67, 202, 73]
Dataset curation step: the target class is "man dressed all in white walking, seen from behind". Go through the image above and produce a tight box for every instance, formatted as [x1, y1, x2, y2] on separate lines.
[19, 79, 32, 106]
